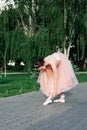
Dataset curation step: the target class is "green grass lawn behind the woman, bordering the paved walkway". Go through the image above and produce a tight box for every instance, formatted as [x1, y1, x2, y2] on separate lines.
[0, 74, 87, 97]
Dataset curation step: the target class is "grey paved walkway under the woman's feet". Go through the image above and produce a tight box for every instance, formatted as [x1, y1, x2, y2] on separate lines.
[0, 83, 87, 130]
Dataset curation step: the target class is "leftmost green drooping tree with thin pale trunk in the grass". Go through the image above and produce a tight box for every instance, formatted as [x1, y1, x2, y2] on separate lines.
[0, 7, 25, 72]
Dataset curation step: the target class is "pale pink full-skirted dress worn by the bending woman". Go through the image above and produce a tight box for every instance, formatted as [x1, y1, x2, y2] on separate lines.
[38, 52, 78, 97]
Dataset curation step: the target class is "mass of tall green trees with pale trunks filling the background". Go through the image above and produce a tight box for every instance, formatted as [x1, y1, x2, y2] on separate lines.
[0, 0, 87, 71]
